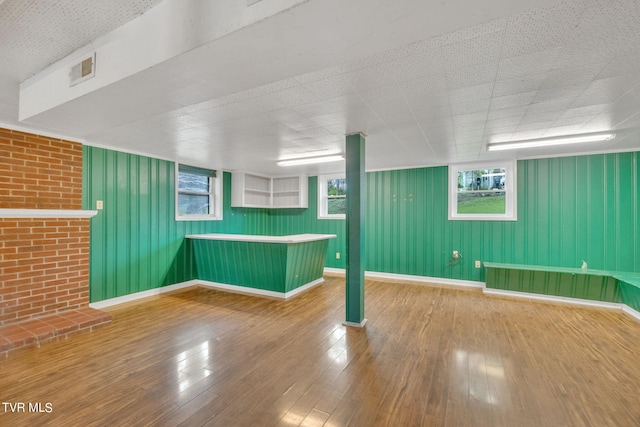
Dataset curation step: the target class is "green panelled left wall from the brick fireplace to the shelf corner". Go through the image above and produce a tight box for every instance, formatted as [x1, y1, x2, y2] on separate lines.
[83, 146, 269, 302]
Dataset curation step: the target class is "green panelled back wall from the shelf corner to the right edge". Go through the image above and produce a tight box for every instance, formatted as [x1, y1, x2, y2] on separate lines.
[272, 152, 640, 281]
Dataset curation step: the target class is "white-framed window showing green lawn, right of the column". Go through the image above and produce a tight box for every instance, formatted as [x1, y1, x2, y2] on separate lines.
[449, 161, 517, 221]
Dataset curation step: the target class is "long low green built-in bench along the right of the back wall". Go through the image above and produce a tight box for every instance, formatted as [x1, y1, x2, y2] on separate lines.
[484, 262, 640, 317]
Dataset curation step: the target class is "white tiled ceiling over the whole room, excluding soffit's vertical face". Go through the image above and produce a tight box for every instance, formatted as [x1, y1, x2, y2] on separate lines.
[0, 0, 640, 174]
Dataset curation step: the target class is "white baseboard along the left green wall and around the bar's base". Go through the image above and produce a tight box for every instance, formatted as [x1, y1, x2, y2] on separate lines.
[89, 278, 324, 310]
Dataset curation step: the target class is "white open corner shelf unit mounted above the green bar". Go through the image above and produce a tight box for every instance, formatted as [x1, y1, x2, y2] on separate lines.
[231, 172, 308, 209]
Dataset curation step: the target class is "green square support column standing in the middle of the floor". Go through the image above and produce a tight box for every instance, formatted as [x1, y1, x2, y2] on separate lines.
[343, 134, 367, 327]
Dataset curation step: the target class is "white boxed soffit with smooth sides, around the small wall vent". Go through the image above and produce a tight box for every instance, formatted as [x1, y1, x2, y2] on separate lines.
[19, 0, 551, 128]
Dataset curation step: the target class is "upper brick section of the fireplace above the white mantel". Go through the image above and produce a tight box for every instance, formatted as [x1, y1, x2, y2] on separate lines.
[0, 128, 82, 209]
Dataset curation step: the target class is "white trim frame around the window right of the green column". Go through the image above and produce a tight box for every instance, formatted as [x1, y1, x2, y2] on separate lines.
[449, 160, 518, 221]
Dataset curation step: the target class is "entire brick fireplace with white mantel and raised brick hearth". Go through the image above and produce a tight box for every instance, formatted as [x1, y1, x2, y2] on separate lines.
[0, 128, 111, 358]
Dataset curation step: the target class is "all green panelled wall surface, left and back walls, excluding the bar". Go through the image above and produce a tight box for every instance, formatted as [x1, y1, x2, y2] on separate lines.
[83, 146, 640, 301]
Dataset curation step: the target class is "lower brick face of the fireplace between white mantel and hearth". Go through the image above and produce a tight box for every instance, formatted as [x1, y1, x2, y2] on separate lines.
[0, 218, 89, 326]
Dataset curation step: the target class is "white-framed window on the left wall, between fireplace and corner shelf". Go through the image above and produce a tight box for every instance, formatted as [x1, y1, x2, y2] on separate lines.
[176, 165, 222, 220]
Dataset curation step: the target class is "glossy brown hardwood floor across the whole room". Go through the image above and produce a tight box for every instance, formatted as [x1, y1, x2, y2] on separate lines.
[0, 277, 640, 427]
